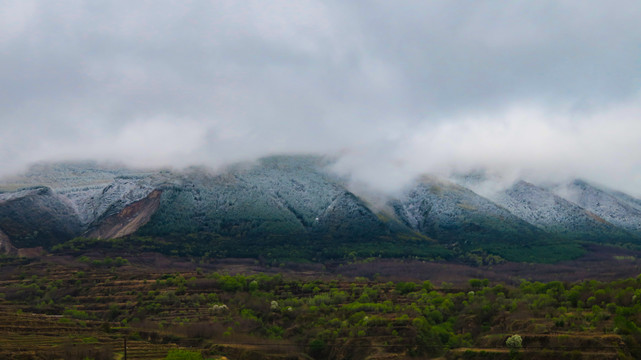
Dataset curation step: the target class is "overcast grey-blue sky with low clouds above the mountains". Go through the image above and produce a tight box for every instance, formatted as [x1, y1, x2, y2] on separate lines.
[0, 0, 641, 196]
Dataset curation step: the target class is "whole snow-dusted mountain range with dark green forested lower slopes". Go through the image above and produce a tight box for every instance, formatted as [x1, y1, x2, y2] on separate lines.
[0, 156, 641, 262]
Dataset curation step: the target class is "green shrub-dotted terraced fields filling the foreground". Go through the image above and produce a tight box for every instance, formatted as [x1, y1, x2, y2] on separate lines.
[0, 254, 641, 359]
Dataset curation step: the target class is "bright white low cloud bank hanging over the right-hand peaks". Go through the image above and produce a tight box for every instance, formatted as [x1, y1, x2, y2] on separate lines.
[335, 96, 641, 196]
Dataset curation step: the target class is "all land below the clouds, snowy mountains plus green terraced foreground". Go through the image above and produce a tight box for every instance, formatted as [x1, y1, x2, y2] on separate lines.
[0, 156, 641, 359]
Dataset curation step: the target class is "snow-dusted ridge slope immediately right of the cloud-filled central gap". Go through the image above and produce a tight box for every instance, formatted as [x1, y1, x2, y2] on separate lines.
[393, 177, 581, 261]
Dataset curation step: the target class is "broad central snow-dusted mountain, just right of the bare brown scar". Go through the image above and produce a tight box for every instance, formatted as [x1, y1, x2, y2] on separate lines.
[138, 157, 433, 258]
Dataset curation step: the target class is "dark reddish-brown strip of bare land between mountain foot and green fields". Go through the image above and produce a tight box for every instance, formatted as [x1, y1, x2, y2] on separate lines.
[6, 245, 641, 287]
